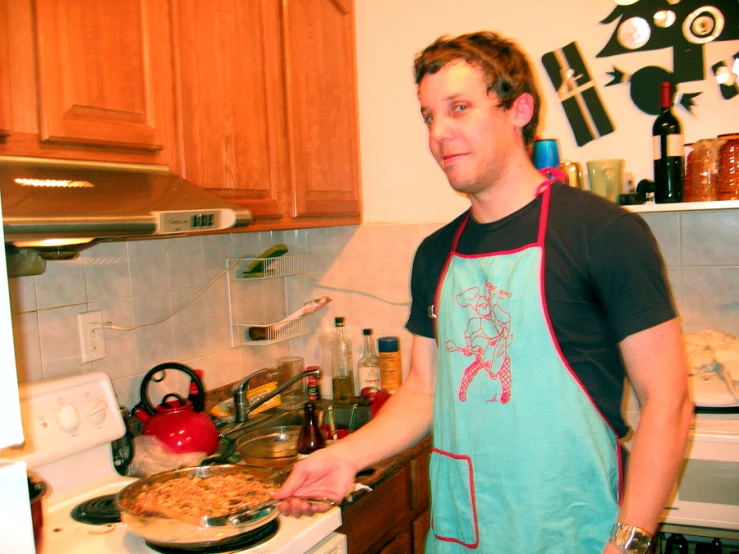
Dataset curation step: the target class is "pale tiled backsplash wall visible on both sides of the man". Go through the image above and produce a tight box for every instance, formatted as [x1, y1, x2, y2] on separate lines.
[10, 210, 739, 407]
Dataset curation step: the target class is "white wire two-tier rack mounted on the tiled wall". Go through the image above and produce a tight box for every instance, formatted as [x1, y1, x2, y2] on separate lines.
[227, 254, 310, 346]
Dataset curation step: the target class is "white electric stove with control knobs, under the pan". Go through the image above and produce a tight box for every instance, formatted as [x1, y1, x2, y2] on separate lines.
[12, 372, 345, 554]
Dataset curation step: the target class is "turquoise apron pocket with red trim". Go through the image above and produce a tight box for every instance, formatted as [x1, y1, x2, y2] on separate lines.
[429, 448, 480, 548]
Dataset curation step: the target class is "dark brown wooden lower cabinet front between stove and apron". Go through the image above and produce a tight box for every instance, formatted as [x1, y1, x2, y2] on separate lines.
[338, 467, 410, 552]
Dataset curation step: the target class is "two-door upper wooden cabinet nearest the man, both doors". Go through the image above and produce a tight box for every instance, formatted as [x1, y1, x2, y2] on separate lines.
[173, 0, 361, 230]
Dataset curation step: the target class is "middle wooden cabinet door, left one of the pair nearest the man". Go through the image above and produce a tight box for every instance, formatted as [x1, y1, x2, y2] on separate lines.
[173, 0, 288, 219]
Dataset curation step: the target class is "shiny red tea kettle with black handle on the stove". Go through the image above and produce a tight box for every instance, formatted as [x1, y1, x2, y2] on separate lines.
[133, 362, 218, 454]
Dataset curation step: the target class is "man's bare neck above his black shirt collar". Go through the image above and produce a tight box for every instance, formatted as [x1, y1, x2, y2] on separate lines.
[470, 159, 546, 223]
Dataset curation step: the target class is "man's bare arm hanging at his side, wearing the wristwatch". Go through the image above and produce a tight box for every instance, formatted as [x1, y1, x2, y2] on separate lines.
[605, 319, 693, 554]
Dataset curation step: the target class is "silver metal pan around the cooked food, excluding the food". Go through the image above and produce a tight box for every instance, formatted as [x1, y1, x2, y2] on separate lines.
[115, 465, 288, 549]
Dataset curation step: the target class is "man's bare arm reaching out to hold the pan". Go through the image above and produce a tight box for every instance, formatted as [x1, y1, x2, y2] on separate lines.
[274, 335, 436, 517]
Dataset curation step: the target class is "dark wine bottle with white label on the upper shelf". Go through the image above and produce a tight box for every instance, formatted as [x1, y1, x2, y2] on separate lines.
[652, 82, 685, 204]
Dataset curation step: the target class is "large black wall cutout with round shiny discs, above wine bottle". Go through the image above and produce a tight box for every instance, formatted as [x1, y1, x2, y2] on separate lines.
[597, 0, 739, 115]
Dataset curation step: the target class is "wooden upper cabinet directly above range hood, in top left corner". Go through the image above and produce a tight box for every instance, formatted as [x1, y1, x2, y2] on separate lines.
[0, 0, 175, 165]
